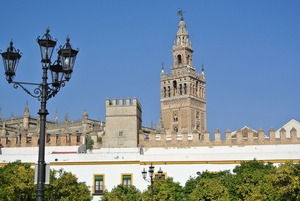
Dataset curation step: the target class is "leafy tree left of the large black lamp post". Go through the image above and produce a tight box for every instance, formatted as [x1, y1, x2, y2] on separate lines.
[0, 161, 36, 201]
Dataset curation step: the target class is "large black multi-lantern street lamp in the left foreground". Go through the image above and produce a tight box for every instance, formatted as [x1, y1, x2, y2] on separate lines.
[1, 29, 79, 201]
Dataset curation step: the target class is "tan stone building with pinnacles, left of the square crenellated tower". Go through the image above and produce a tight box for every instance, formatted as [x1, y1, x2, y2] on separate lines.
[0, 104, 105, 151]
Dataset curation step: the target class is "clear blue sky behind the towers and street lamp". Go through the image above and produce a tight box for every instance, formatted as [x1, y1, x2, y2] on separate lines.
[0, 0, 300, 133]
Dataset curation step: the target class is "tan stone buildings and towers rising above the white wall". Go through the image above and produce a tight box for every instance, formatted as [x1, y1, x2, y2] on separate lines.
[0, 18, 300, 153]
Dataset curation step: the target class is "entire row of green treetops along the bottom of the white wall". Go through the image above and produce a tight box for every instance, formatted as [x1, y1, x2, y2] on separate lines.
[0, 160, 300, 201]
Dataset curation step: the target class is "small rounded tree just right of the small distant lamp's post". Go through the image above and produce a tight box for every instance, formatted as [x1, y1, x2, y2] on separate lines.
[142, 178, 185, 201]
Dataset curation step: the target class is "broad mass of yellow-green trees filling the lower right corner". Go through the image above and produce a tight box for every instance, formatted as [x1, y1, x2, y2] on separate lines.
[184, 160, 300, 201]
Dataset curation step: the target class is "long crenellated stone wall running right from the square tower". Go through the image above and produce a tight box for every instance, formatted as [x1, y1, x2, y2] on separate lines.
[139, 127, 300, 147]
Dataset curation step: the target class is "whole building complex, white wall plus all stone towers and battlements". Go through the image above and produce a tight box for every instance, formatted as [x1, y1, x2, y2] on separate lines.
[0, 13, 300, 201]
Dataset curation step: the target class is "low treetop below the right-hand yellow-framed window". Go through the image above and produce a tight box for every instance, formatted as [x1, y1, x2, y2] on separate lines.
[101, 185, 142, 201]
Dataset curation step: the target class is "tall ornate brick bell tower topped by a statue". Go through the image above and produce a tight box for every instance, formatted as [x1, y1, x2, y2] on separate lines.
[160, 14, 206, 134]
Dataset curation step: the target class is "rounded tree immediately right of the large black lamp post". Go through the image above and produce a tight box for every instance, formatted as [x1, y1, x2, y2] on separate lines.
[45, 169, 92, 201]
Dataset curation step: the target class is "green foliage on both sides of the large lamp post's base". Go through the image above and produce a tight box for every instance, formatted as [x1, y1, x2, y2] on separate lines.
[0, 161, 92, 201]
